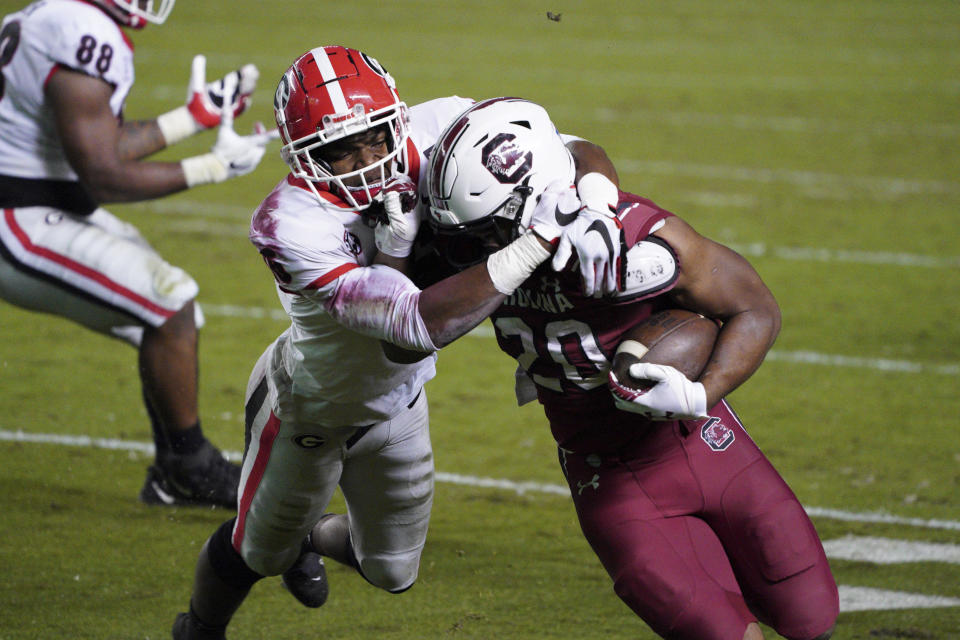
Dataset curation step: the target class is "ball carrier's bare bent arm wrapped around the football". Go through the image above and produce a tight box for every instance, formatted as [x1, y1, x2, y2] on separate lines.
[654, 218, 780, 407]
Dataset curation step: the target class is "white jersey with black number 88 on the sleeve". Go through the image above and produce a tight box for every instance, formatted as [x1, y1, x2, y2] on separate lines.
[0, 0, 134, 180]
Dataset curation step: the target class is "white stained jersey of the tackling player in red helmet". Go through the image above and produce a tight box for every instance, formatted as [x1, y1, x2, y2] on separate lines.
[250, 97, 472, 427]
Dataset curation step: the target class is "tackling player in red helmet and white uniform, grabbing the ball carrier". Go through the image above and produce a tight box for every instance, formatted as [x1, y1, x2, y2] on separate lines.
[173, 46, 616, 640]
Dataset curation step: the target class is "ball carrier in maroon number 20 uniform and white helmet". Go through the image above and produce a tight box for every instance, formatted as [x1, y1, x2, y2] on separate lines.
[428, 98, 838, 640]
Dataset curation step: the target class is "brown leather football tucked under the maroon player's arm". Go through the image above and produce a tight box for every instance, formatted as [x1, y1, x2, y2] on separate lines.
[611, 309, 720, 390]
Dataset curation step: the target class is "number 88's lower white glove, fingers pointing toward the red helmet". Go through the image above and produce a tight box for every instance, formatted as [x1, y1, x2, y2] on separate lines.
[180, 75, 280, 187]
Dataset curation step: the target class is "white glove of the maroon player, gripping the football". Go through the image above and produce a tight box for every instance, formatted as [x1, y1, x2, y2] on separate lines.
[609, 362, 708, 420]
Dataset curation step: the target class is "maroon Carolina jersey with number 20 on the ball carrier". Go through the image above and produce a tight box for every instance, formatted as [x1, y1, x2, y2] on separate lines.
[491, 191, 675, 448]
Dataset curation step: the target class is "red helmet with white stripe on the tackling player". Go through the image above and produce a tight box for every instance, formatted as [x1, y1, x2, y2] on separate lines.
[273, 46, 410, 211]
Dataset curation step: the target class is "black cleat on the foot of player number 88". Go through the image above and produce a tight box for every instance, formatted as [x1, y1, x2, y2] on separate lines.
[140, 442, 240, 509]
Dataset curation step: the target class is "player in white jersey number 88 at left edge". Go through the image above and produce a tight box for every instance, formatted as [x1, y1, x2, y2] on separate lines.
[0, 0, 271, 507]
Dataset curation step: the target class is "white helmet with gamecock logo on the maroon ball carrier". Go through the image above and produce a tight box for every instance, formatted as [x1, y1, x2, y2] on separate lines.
[427, 98, 576, 267]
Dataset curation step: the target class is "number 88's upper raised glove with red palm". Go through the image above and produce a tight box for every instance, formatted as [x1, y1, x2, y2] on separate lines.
[157, 55, 260, 146]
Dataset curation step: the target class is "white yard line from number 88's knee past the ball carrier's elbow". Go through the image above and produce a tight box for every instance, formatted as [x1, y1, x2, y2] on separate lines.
[202, 303, 960, 376]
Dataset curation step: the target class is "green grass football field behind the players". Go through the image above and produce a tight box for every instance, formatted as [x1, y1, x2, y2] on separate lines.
[0, 0, 960, 640]
